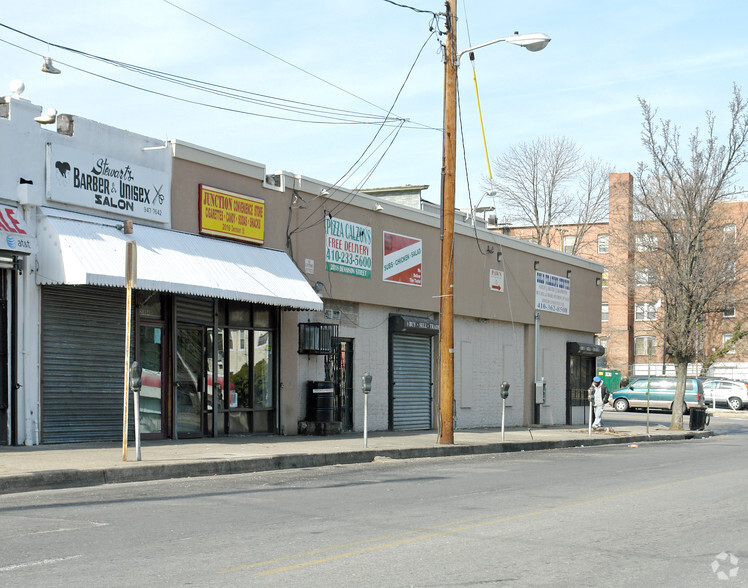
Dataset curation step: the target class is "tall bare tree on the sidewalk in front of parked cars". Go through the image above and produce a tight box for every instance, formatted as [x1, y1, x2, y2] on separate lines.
[634, 86, 748, 429]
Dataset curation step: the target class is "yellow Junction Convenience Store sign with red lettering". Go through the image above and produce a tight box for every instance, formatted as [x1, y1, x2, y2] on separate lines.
[200, 184, 265, 245]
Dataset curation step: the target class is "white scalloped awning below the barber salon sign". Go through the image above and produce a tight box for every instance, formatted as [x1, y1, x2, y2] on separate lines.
[36, 210, 322, 310]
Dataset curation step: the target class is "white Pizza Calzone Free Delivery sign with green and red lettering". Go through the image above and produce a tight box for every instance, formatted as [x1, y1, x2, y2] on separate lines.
[325, 217, 371, 278]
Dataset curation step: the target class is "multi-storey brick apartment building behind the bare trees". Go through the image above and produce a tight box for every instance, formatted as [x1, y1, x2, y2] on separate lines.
[495, 173, 748, 379]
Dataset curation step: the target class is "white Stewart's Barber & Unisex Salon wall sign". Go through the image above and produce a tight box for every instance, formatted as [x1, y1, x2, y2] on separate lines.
[47, 143, 171, 223]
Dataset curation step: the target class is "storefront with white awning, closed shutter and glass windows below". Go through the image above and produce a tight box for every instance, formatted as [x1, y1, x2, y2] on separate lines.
[37, 209, 321, 443]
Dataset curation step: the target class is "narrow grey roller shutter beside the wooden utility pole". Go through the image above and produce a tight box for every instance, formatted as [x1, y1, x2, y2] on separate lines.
[391, 333, 431, 430]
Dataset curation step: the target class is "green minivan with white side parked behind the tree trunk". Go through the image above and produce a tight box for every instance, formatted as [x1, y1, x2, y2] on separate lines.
[612, 376, 704, 413]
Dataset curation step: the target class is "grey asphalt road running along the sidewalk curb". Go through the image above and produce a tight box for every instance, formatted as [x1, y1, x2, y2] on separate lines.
[0, 413, 748, 587]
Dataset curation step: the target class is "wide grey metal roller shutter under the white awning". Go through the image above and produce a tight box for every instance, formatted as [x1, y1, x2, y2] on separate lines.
[41, 286, 134, 443]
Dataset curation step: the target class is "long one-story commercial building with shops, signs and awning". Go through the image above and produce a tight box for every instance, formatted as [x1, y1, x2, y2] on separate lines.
[0, 86, 602, 445]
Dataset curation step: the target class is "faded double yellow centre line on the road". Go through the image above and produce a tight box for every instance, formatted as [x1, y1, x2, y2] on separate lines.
[217, 470, 742, 576]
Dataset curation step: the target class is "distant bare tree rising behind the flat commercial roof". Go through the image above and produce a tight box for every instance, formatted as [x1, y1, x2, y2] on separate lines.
[489, 137, 611, 253]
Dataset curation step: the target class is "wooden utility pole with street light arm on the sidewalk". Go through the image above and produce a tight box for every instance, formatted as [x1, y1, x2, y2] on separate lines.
[439, 0, 551, 444]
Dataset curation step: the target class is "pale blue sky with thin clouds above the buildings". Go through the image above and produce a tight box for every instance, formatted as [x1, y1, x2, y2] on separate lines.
[0, 0, 748, 211]
